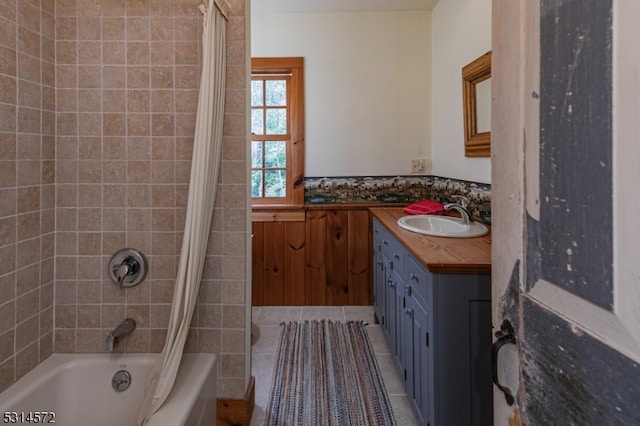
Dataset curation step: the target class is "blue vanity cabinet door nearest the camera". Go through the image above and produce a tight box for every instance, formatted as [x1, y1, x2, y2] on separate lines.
[404, 297, 434, 425]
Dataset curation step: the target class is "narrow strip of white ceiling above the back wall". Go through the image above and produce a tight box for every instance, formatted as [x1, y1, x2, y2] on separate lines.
[251, 0, 438, 13]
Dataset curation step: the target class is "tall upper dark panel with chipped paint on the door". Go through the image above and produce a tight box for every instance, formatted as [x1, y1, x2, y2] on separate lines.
[539, 0, 613, 310]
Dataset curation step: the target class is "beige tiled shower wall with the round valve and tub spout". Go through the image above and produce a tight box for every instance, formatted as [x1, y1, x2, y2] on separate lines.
[0, 0, 247, 397]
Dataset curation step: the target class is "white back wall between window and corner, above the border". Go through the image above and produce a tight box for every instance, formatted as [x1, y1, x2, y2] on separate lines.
[251, 10, 430, 177]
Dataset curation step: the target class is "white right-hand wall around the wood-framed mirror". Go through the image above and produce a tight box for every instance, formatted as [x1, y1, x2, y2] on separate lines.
[431, 0, 491, 183]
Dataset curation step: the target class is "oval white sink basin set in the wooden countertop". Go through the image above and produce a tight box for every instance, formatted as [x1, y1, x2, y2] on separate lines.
[398, 215, 489, 238]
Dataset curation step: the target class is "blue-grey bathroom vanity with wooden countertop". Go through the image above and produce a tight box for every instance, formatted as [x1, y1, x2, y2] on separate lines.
[370, 208, 493, 426]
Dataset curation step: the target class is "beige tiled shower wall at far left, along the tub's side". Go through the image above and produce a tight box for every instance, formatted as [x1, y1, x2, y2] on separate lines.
[0, 0, 55, 391]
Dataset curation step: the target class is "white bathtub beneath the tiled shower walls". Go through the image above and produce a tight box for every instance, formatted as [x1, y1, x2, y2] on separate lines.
[0, 353, 217, 426]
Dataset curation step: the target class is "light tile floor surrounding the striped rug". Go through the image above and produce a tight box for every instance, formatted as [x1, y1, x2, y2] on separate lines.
[251, 306, 417, 426]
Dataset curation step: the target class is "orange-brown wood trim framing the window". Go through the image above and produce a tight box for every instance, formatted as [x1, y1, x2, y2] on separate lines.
[251, 57, 304, 207]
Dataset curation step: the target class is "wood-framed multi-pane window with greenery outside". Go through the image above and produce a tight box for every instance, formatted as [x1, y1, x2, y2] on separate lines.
[251, 58, 304, 206]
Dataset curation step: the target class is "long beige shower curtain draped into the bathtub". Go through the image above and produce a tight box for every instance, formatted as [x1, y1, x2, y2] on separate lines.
[138, 0, 230, 425]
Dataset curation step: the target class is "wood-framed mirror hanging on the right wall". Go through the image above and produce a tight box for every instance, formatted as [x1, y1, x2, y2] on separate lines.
[462, 52, 491, 157]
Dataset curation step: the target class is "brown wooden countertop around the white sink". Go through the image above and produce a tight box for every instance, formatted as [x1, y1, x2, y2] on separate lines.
[369, 207, 491, 274]
